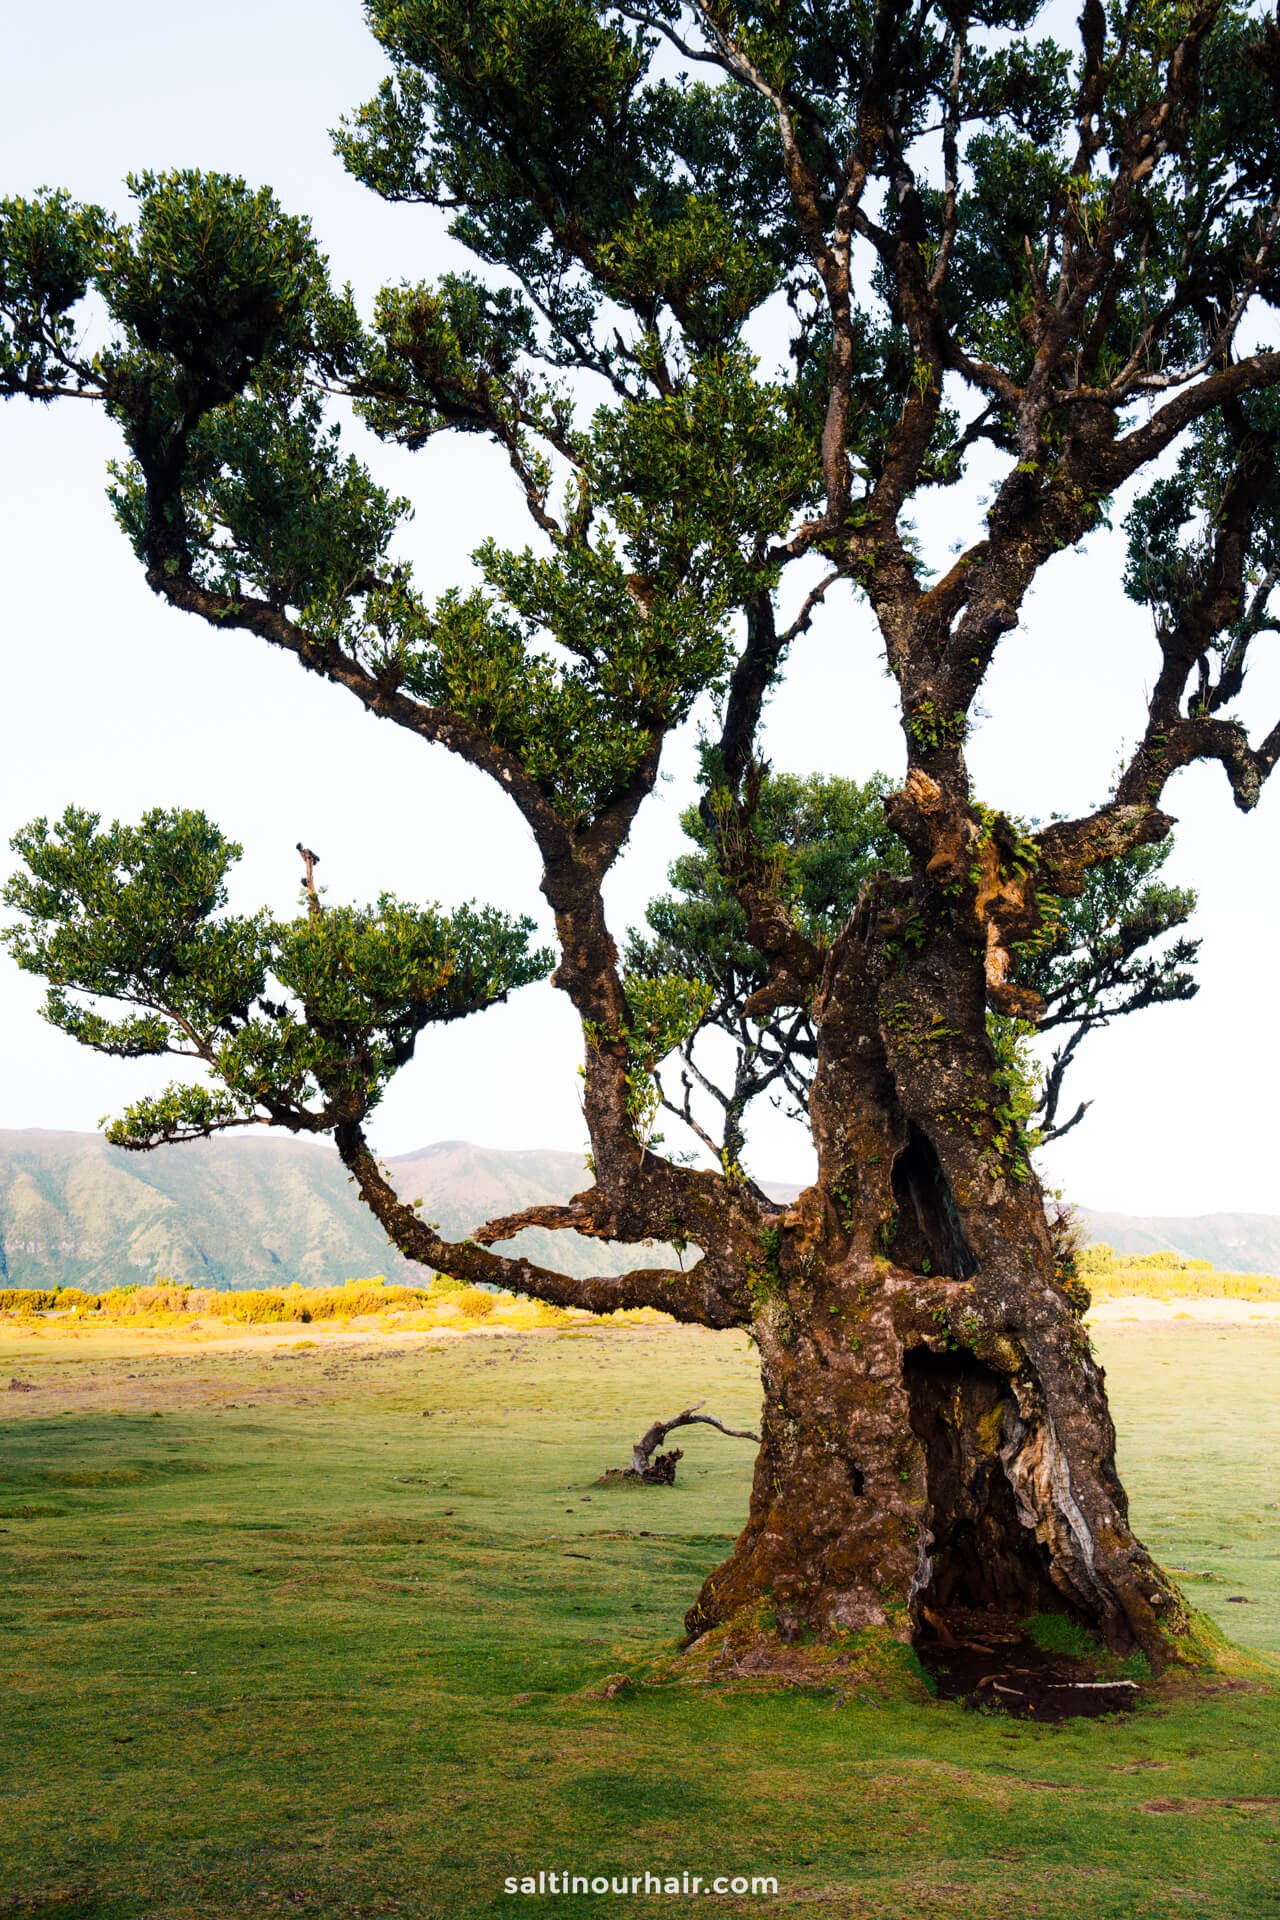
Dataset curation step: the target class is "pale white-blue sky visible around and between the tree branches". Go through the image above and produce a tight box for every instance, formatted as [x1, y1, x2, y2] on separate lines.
[0, 0, 1280, 1213]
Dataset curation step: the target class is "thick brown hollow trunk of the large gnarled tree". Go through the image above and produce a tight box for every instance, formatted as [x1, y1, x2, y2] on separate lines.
[687, 913, 1188, 1667]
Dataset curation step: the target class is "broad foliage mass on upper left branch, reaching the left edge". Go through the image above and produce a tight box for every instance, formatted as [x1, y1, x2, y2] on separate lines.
[0, 153, 805, 826]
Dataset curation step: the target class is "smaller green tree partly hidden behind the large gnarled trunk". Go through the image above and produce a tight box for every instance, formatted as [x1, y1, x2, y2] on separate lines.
[626, 774, 1199, 1167]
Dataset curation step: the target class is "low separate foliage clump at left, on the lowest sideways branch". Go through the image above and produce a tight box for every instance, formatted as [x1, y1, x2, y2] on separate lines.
[4, 808, 549, 1146]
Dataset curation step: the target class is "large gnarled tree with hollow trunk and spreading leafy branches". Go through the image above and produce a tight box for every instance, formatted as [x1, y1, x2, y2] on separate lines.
[0, 0, 1280, 1665]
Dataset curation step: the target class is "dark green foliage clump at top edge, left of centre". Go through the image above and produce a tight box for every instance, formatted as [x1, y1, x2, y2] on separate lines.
[338, 0, 796, 372]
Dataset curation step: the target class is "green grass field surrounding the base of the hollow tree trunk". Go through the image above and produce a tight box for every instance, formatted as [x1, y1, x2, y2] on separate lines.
[0, 1323, 1280, 1920]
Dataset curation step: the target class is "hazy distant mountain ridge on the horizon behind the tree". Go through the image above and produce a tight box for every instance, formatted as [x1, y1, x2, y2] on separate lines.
[0, 1129, 1280, 1292]
